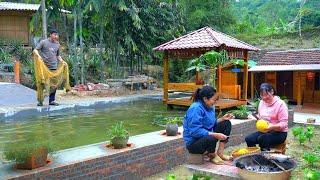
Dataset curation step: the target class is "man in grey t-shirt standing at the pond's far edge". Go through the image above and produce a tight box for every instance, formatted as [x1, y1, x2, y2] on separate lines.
[36, 29, 63, 106]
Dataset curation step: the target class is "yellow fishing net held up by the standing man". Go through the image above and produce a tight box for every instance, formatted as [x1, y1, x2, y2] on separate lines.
[33, 50, 71, 102]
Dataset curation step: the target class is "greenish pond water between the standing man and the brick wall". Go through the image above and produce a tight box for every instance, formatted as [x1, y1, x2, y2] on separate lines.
[0, 99, 185, 152]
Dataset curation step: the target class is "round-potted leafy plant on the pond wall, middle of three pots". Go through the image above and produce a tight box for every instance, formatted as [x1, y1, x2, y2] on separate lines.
[108, 121, 129, 149]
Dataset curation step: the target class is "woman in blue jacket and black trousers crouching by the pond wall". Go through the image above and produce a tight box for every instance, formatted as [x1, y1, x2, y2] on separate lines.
[183, 86, 234, 164]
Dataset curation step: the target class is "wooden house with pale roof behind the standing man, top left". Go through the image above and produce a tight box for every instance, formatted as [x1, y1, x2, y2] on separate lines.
[0, 2, 40, 45]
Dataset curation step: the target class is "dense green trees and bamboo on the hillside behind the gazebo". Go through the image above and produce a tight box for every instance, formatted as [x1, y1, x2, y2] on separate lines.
[0, 0, 320, 84]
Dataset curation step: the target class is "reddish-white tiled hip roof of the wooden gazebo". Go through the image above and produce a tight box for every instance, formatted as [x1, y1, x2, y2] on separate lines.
[153, 27, 259, 51]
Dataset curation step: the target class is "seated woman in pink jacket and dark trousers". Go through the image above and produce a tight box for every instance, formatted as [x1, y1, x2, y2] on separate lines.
[245, 83, 288, 151]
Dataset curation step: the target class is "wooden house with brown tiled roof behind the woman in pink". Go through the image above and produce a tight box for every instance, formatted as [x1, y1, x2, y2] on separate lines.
[249, 49, 320, 105]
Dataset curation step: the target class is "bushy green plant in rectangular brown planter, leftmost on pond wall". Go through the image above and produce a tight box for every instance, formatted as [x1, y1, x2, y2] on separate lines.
[4, 140, 53, 170]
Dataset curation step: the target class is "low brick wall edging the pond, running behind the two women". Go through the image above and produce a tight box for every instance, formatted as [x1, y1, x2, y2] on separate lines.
[7, 112, 293, 179]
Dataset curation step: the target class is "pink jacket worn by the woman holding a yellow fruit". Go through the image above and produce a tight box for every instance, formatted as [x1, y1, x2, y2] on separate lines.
[258, 96, 288, 132]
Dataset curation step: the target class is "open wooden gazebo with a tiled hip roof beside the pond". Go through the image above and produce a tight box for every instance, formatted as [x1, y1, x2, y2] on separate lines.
[153, 27, 259, 109]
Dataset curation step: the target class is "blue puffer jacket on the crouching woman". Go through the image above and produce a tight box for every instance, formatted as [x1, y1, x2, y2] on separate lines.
[183, 102, 217, 146]
